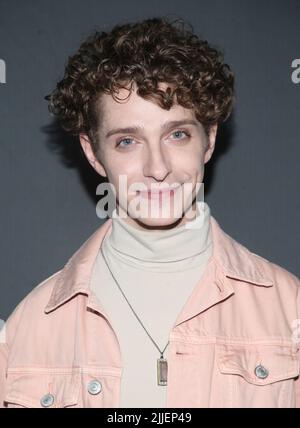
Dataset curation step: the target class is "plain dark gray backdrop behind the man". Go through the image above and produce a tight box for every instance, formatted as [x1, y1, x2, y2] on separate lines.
[0, 0, 300, 319]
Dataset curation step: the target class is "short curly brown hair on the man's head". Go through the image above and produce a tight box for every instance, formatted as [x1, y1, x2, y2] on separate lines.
[45, 17, 234, 153]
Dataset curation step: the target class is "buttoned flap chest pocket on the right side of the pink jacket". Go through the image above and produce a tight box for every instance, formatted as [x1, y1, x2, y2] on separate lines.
[216, 343, 299, 408]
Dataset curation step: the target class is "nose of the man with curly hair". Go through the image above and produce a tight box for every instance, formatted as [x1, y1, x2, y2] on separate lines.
[143, 147, 171, 181]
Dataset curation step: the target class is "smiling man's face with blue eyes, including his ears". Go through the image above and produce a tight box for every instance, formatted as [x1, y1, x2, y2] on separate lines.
[80, 85, 217, 229]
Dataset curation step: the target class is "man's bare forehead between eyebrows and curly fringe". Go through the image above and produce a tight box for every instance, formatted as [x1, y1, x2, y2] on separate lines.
[101, 84, 195, 129]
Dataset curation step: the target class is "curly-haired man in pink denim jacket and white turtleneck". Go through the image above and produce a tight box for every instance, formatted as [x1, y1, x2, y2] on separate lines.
[0, 14, 300, 407]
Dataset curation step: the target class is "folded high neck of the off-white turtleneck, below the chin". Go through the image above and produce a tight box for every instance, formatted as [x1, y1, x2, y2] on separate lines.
[106, 201, 211, 265]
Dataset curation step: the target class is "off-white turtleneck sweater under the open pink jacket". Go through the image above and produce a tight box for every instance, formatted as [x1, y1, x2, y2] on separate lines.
[91, 202, 212, 408]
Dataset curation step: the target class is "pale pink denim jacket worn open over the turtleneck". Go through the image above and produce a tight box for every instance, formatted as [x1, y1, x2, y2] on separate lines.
[0, 216, 300, 408]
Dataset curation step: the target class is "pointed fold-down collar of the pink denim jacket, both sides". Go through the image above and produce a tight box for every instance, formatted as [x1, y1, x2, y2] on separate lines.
[45, 215, 273, 313]
